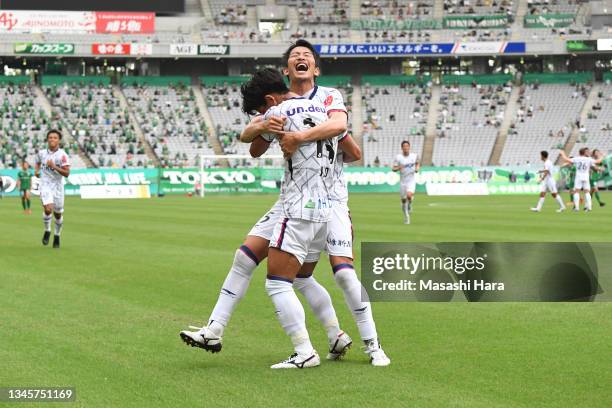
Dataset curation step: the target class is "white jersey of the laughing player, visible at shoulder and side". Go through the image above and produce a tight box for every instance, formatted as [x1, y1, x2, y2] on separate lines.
[302, 85, 348, 204]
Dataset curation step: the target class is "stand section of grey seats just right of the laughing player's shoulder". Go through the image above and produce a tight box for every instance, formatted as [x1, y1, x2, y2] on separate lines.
[362, 76, 431, 167]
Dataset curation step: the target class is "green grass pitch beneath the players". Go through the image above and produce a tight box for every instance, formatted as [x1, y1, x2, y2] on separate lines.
[0, 194, 612, 408]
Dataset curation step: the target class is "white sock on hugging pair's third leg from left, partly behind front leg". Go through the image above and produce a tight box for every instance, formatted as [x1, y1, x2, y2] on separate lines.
[293, 276, 341, 341]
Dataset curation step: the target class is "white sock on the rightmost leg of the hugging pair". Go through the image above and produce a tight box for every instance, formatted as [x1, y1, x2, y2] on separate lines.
[334, 264, 378, 341]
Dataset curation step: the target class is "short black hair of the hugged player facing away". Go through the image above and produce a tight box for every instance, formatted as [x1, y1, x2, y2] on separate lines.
[240, 68, 289, 115]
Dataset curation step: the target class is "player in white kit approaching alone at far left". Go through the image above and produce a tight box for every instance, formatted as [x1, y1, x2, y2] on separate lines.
[36, 130, 70, 248]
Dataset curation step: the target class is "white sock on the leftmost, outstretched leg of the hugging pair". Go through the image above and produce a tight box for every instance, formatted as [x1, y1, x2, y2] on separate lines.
[208, 245, 257, 337]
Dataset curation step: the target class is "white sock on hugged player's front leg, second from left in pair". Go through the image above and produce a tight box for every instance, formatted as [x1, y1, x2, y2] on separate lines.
[266, 278, 313, 354]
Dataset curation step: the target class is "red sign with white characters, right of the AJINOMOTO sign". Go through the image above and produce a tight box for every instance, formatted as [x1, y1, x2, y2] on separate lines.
[96, 11, 155, 34]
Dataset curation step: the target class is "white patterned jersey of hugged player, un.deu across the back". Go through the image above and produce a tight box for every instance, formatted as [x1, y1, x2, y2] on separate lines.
[264, 97, 338, 222]
